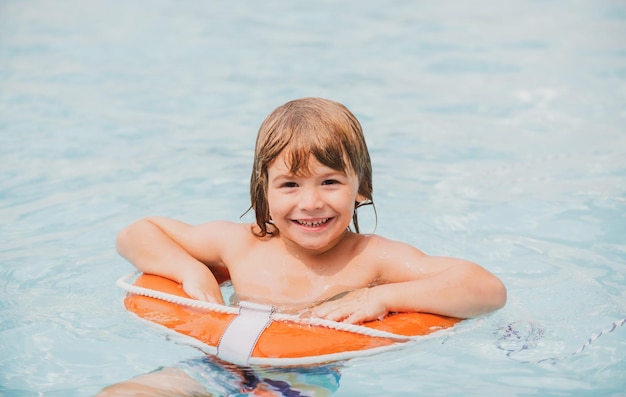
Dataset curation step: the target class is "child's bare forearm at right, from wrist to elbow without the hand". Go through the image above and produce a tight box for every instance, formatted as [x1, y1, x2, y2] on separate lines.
[372, 262, 506, 318]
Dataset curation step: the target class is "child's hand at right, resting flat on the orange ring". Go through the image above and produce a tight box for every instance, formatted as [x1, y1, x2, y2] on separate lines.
[311, 288, 388, 324]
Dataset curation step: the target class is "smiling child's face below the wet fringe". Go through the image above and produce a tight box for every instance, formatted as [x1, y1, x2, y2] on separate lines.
[267, 150, 359, 253]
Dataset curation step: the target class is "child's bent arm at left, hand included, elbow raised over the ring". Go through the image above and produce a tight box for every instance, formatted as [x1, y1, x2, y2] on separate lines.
[117, 217, 232, 303]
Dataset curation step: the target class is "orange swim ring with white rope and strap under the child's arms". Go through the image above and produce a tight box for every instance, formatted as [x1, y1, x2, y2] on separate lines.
[117, 274, 459, 366]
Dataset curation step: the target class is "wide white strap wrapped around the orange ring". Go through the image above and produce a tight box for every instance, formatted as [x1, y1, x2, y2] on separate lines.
[217, 302, 274, 365]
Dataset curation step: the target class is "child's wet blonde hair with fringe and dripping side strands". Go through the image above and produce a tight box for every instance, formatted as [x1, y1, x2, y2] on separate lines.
[250, 98, 373, 237]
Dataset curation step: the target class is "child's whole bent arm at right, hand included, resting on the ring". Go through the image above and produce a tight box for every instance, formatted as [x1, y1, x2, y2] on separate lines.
[314, 238, 506, 323]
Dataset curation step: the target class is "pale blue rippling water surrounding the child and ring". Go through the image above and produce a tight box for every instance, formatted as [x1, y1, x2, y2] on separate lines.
[0, 0, 626, 397]
